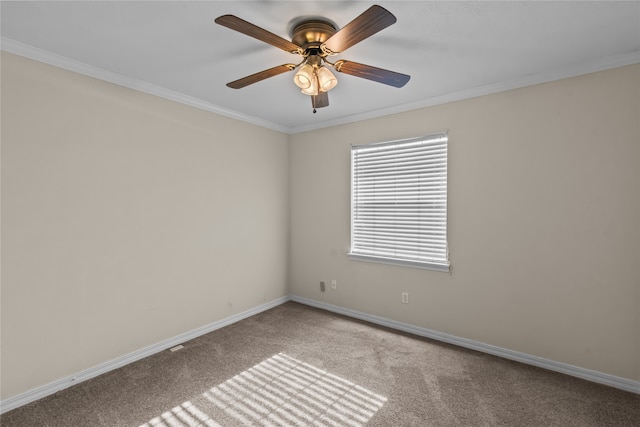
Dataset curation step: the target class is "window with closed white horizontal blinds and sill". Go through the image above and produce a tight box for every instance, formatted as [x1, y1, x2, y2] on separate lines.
[349, 133, 449, 271]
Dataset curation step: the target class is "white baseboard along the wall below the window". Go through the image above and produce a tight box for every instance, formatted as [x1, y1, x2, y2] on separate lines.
[291, 295, 640, 394]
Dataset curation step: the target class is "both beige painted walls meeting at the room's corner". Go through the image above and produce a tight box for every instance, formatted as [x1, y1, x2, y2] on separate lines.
[1, 53, 640, 399]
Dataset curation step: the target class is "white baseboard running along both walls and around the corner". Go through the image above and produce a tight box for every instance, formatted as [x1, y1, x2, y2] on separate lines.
[0, 295, 640, 414]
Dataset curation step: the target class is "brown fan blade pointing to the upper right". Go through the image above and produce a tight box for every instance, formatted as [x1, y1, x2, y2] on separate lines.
[323, 5, 396, 53]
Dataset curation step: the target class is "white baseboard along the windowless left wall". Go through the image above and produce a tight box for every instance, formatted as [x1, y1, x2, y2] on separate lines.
[0, 296, 291, 414]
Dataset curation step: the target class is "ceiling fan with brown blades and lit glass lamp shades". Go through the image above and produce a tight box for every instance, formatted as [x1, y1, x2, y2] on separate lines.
[215, 5, 411, 113]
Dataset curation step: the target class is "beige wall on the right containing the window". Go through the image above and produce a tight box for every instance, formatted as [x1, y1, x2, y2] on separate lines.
[290, 66, 640, 380]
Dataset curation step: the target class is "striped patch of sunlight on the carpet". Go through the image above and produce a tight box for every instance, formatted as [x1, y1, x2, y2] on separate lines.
[140, 353, 387, 427]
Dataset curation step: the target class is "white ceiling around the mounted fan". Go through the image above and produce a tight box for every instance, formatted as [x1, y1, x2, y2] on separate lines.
[0, 1, 640, 133]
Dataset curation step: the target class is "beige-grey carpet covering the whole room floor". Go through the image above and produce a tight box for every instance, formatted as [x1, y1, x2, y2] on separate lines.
[0, 302, 640, 427]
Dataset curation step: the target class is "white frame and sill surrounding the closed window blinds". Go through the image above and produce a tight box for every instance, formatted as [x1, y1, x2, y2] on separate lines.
[347, 132, 451, 272]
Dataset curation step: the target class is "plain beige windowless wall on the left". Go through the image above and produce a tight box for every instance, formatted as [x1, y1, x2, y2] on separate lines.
[1, 53, 289, 399]
